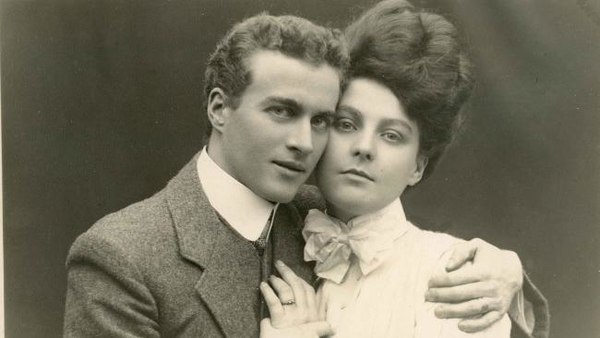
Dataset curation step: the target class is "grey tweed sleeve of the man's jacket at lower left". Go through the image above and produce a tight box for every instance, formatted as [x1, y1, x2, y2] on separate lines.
[64, 233, 160, 337]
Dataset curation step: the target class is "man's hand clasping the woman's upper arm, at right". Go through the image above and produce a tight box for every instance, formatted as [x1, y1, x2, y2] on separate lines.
[425, 238, 523, 332]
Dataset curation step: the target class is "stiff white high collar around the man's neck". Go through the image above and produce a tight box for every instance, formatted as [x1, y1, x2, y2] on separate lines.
[196, 147, 275, 241]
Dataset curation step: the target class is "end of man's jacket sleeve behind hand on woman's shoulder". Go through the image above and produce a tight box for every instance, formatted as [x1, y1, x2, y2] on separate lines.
[508, 272, 550, 338]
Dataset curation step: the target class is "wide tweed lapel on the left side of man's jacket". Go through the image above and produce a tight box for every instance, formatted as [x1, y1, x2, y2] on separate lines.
[167, 155, 260, 337]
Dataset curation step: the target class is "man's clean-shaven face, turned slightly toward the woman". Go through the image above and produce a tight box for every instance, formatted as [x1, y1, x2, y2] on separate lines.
[211, 50, 340, 202]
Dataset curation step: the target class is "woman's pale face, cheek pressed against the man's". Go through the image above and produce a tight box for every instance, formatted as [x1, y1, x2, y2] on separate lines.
[316, 78, 427, 221]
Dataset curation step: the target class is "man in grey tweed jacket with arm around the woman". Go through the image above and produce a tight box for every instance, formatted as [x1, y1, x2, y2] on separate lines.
[64, 11, 548, 337]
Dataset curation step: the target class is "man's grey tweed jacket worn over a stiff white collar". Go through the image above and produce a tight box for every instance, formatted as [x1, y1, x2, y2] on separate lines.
[64, 155, 313, 337]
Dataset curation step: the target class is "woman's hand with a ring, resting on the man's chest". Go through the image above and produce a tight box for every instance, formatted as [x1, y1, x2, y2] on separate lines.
[260, 261, 321, 329]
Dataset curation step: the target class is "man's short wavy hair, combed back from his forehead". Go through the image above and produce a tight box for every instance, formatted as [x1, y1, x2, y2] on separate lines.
[204, 13, 349, 135]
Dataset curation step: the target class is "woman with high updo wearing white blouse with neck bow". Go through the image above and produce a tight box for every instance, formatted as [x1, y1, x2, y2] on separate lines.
[261, 1, 510, 338]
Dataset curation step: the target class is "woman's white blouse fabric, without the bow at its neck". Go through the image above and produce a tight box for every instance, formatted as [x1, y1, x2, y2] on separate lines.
[310, 200, 511, 338]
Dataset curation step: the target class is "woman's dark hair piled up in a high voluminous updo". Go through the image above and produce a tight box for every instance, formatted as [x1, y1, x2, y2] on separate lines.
[346, 0, 473, 178]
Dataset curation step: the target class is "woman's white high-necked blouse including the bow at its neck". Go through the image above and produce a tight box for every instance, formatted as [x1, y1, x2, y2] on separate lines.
[303, 200, 511, 338]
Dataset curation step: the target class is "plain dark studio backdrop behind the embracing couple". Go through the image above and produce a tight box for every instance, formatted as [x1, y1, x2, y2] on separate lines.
[0, 0, 600, 337]
